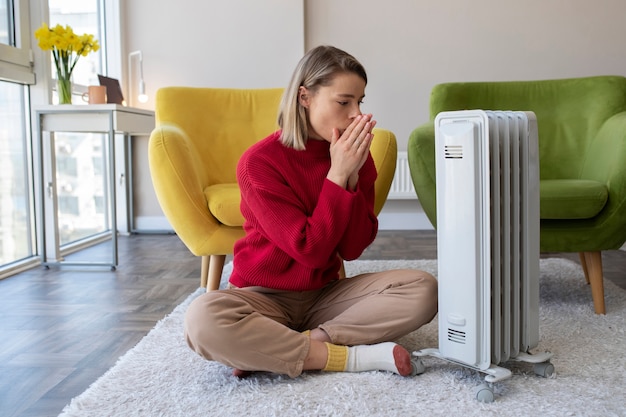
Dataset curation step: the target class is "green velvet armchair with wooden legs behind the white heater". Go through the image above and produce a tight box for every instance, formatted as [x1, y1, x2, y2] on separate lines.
[407, 76, 626, 314]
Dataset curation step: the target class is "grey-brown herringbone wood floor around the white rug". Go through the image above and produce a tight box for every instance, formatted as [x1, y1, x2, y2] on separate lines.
[0, 231, 626, 417]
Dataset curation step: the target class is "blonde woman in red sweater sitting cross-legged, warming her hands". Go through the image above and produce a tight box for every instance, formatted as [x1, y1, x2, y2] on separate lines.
[185, 46, 437, 377]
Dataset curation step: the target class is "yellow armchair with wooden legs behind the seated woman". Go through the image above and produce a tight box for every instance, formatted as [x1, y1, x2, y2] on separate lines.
[148, 87, 397, 290]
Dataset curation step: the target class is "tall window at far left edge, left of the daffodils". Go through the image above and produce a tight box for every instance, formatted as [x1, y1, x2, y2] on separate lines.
[0, 0, 36, 277]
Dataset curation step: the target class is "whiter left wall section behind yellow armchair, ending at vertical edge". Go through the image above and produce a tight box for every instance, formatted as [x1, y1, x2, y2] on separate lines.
[121, 0, 304, 230]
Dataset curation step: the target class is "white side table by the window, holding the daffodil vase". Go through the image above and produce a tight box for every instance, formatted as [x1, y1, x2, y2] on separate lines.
[34, 104, 154, 269]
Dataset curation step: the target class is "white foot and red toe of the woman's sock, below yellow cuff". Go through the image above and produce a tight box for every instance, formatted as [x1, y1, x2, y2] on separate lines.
[345, 342, 412, 376]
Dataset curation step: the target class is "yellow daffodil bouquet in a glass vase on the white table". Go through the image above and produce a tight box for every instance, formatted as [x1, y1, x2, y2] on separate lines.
[35, 23, 100, 104]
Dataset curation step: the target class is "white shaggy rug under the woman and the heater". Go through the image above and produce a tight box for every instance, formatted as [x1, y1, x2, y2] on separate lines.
[61, 259, 626, 417]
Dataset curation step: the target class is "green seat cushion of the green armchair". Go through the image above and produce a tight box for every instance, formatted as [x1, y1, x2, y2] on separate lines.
[539, 180, 609, 219]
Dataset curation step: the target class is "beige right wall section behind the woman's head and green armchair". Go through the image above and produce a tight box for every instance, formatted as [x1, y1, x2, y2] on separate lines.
[306, 0, 626, 150]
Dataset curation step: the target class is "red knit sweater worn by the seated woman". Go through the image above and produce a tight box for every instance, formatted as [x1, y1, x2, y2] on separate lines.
[230, 132, 378, 291]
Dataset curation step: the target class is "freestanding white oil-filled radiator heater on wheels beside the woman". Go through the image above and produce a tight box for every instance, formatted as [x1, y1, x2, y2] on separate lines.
[414, 110, 554, 402]
